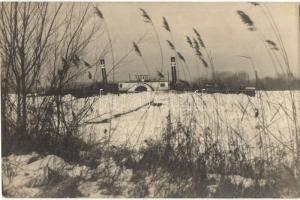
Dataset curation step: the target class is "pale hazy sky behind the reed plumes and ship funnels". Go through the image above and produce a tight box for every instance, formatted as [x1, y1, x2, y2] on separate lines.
[68, 2, 300, 80]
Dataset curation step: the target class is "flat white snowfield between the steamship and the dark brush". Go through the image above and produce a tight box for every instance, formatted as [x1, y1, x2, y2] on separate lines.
[74, 91, 300, 156]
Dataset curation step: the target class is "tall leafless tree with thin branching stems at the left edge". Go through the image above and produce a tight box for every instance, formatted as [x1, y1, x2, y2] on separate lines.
[0, 3, 100, 158]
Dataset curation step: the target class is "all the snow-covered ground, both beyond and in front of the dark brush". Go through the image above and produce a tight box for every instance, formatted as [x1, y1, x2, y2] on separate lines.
[2, 91, 300, 197]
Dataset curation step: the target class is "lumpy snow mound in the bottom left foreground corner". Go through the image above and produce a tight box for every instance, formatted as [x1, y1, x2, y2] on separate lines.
[2, 153, 91, 197]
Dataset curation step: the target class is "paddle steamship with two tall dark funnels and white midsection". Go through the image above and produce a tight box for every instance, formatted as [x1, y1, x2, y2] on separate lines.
[38, 57, 255, 98]
